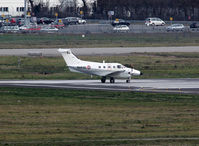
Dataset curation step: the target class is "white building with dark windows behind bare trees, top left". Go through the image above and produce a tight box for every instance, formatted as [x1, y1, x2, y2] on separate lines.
[0, 0, 59, 16]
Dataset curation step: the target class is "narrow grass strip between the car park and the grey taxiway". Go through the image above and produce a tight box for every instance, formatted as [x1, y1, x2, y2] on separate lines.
[0, 33, 199, 49]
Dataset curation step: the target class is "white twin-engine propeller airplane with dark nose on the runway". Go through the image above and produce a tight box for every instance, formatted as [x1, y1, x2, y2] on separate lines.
[58, 49, 142, 83]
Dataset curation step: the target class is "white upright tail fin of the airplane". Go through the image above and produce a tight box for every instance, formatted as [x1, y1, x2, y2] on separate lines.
[58, 49, 81, 66]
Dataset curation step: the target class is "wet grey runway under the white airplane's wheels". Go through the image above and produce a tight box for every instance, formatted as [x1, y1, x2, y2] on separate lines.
[0, 78, 199, 94]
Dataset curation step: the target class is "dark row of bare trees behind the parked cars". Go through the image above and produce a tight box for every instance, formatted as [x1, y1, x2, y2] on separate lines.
[29, 0, 199, 21]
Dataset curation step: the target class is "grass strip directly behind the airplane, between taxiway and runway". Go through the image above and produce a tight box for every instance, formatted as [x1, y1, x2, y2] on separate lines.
[0, 53, 199, 79]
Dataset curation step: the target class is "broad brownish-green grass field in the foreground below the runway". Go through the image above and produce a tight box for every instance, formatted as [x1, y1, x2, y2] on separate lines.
[0, 87, 199, 145]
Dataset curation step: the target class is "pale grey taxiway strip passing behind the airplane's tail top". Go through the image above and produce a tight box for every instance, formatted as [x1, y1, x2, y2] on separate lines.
[0, 46, 199, 56]
